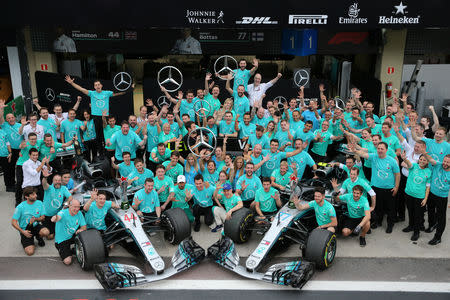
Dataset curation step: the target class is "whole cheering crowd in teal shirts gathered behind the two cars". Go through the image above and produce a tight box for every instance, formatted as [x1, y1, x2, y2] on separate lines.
[4, 60, 450, 264]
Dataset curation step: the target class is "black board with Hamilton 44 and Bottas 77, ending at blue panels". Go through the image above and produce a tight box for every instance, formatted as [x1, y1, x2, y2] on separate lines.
[31, 27, 281, 55]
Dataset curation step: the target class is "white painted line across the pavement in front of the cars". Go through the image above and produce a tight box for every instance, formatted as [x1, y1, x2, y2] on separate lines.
[0, 279, 450, 293]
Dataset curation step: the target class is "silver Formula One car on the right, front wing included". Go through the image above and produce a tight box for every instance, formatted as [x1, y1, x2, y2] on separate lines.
[207, 164, 342, 288]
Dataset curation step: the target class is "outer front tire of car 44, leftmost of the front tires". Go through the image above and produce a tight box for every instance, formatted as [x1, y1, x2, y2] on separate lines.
[75, 229, 106, 271]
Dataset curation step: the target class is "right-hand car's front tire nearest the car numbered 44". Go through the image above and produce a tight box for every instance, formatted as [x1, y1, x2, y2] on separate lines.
[224, 207, 253, 244]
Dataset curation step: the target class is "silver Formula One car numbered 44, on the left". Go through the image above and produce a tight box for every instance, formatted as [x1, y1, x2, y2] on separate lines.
[74, 181, 205, 291]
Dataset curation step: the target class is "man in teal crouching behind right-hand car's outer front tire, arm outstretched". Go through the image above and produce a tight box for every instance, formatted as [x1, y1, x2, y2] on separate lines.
[293, 186, 337, 232]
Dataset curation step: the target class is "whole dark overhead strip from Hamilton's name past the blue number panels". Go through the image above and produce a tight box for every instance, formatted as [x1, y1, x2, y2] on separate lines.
[31, 26, 382, 55]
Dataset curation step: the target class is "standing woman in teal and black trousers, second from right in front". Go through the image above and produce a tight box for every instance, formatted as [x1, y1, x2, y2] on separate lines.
[402, 151, 431, 241]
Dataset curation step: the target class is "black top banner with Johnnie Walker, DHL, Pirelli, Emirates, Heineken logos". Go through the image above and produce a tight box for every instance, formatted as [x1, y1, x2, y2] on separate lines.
[4, 0, 440, 27]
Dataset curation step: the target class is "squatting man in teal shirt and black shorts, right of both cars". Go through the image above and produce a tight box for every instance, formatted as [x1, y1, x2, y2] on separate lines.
[337, 185, 370, 247]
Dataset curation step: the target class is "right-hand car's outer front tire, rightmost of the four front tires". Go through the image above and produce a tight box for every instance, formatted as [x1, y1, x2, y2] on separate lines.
[304, 228, 337, 270]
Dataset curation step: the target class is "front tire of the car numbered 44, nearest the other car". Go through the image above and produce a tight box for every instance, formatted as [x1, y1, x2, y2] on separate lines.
[161, 207, 191, 245]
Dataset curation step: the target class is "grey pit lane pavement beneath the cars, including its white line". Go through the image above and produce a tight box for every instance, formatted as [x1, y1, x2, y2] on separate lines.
[0, 179, 450, 300]
